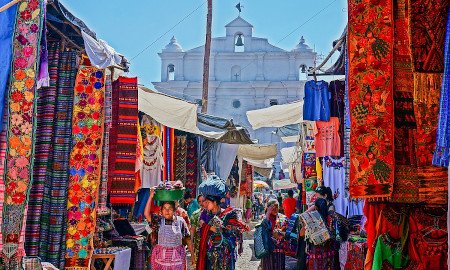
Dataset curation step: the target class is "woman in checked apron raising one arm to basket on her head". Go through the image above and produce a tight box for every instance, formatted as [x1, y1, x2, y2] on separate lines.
[145, 189, 193, 270]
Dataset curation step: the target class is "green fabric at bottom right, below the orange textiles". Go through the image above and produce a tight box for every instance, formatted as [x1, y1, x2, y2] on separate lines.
[372, 234, 409, 270]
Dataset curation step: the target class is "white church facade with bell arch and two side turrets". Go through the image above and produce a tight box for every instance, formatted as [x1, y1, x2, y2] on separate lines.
[153, 16, 316, 158]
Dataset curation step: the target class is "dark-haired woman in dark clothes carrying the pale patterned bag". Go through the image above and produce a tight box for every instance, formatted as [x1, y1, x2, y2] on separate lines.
[307, 186, 340, 270]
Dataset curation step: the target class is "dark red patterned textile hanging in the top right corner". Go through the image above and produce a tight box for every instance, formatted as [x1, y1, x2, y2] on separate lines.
[409, 0, 449, 72]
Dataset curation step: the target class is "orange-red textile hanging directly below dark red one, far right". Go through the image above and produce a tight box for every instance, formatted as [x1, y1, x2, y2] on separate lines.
[414, 73, 448, 204]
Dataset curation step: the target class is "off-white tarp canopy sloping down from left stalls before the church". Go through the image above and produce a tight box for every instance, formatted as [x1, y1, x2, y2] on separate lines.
[138, 88, 226, 140]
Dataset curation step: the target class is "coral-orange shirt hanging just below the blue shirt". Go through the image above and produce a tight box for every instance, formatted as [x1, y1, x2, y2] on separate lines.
[314, 117, 341, 157]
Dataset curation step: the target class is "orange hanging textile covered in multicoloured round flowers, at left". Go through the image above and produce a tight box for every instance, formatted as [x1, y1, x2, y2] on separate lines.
[65, 62, 106, 270]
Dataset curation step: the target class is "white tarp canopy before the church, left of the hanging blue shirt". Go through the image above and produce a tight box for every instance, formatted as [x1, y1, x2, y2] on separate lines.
[247, 100, 303, 129]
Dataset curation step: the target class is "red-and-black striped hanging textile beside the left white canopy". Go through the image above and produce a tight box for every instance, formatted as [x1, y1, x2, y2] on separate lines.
[109, 77, 138, 205]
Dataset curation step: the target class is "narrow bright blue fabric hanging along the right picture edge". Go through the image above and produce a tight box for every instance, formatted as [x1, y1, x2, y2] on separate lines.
[433, 9, 450, 167]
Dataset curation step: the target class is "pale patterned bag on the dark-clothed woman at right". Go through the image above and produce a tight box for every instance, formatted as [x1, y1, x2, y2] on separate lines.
[300, 211, 331, 246]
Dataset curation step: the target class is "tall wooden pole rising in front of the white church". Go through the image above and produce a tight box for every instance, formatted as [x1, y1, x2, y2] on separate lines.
[202, 0, 213, 113]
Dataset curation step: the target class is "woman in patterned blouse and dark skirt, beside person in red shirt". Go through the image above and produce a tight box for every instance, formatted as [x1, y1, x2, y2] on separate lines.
[261, 199, 286, 270]
